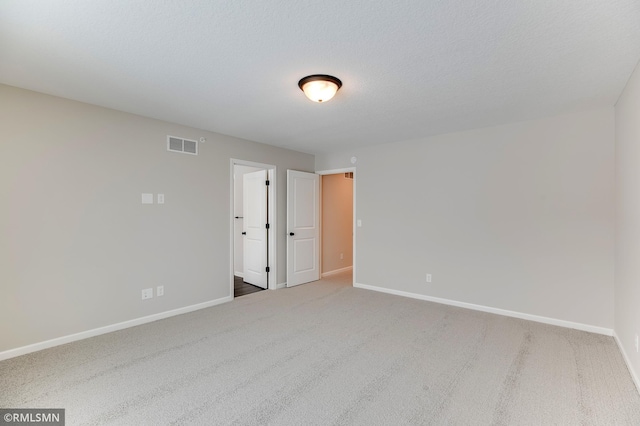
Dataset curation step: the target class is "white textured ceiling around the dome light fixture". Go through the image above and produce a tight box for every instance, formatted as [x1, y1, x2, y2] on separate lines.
[0, 0, 640, 153]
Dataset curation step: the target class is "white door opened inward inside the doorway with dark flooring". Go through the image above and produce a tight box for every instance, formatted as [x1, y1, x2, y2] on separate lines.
[242, 170, 268, 288]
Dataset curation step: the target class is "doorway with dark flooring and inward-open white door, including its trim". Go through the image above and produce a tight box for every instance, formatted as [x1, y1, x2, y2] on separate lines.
[230, 159, 277, 297]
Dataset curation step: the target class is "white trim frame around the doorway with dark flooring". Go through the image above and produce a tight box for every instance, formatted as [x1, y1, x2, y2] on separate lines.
[229, 158, 278, 299]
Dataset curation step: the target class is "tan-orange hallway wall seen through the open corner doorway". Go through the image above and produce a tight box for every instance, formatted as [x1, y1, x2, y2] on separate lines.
[322, 173, 353, 273]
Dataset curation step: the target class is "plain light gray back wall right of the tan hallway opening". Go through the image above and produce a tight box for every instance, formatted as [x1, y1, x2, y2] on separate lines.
[316, 108, 614, 330]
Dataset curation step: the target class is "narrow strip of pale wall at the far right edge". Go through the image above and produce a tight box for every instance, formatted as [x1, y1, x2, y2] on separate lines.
[615, 60, 640, 387]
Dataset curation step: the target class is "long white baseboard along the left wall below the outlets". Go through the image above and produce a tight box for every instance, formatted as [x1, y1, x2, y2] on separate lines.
[0, 296, 233, 361]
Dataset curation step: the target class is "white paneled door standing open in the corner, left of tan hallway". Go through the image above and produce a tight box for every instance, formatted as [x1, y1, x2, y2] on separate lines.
[287, 170, 320, 287]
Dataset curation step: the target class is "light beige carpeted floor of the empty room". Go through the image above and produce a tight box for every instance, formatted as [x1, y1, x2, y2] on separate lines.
[0, 275, 640, 425]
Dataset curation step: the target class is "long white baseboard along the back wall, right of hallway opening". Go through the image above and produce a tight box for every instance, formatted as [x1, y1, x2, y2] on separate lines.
[353, 283, 613, 336]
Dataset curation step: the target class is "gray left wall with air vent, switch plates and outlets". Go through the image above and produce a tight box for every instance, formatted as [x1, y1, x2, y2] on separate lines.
[0, 86, 314, 352]
